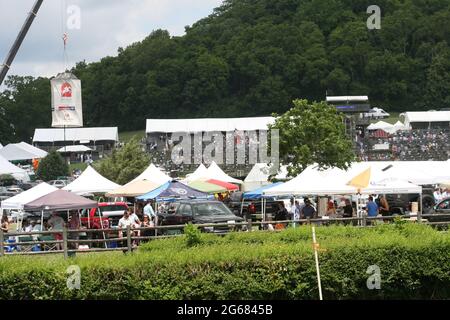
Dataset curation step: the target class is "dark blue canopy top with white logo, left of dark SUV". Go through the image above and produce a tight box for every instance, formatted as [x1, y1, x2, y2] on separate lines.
[136, 181, 214, 200]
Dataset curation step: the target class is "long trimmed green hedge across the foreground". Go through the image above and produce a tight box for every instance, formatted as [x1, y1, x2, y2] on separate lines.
[0, 224, 450, 300]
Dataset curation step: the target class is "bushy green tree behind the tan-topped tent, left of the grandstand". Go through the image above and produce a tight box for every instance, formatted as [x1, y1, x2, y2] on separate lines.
[94, 138, 150, 184]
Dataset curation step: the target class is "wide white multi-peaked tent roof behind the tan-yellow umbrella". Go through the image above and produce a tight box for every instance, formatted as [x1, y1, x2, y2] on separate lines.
[263, 162, 422, 196]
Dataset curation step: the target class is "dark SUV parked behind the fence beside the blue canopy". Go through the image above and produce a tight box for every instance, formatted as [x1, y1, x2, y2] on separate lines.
[158, 200, 244, 233]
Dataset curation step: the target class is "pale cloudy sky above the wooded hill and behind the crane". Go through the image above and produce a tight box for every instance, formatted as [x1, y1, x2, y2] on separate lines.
[0, 0, 222, 81]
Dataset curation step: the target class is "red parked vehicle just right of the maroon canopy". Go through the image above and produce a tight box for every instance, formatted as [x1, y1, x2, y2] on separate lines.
[81, 202, 128, 229]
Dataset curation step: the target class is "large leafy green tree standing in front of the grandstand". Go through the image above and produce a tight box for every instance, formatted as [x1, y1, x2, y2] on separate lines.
[270, 100, 355, 176]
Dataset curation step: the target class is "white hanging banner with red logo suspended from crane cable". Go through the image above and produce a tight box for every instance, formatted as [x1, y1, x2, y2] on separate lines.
[50, 72, 83, 128]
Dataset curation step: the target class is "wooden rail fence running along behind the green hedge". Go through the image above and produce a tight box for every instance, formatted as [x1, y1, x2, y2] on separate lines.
[0, 214, 450, 258]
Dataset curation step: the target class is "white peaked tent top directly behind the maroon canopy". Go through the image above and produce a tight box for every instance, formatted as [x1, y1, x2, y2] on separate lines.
[63, 166, 120, 195]
